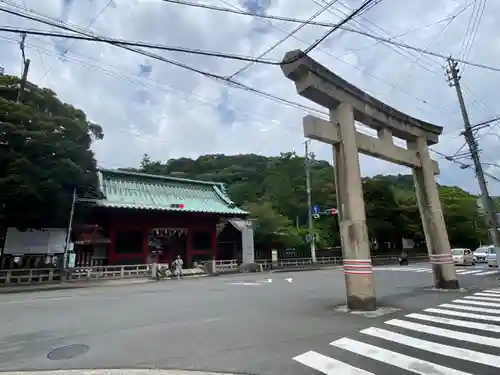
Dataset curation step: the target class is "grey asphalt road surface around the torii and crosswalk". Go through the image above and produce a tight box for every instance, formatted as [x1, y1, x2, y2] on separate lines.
[0, 266, 500, 375]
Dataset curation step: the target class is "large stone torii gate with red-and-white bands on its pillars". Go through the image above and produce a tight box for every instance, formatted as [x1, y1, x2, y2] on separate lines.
[281, 50, 459, 310]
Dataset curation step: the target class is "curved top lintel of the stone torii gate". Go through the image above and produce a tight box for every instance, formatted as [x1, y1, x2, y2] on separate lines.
[281, 50, 443, 145]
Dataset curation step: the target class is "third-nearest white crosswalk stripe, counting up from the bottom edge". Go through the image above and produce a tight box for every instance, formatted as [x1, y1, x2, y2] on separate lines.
[361, 327, 500, 367]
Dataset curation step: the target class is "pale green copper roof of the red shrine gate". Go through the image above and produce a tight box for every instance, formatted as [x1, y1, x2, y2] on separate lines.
[98, 169, 247, 215]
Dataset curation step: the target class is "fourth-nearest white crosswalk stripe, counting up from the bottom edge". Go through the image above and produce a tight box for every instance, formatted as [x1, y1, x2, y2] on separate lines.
[385, 319, 500, 348]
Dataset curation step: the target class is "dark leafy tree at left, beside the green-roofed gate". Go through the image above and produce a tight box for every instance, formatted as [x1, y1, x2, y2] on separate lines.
[0, 76, 103, 228]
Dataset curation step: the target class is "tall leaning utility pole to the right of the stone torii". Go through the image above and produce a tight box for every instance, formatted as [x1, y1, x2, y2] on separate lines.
[446, 58, 500, 246]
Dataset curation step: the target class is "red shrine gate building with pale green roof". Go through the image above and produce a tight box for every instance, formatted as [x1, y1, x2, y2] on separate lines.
[74, 170, 247, 267]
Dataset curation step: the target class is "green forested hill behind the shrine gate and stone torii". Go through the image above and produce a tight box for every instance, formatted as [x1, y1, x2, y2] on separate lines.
[127, 153, 486, 253]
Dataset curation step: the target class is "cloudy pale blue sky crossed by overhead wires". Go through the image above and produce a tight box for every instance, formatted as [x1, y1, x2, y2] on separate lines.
[0, 0, 500, 195]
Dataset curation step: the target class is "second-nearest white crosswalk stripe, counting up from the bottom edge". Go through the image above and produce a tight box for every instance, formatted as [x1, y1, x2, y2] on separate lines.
[330, 337, 472, 375]
